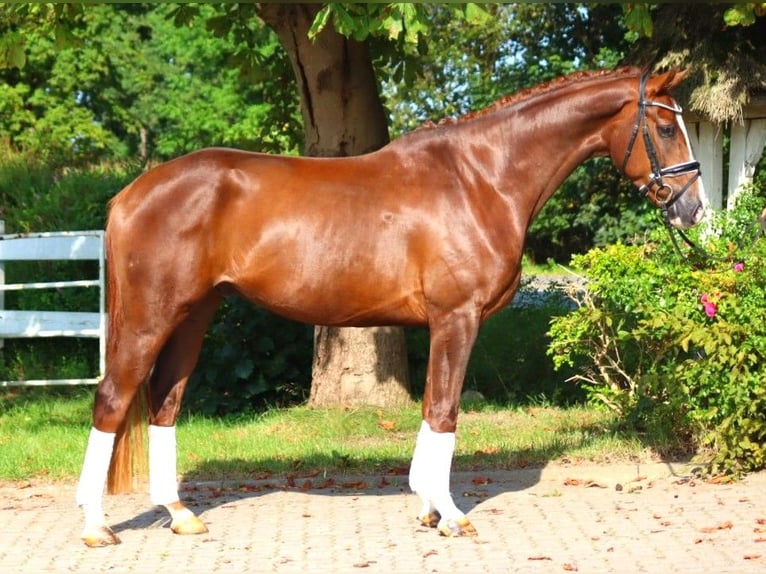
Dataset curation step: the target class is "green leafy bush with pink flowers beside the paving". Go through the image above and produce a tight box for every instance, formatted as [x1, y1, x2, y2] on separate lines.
[549, 189, 766, 473]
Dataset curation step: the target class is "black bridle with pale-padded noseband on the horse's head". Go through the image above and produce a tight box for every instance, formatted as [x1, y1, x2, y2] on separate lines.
[622, 73, 701, 216]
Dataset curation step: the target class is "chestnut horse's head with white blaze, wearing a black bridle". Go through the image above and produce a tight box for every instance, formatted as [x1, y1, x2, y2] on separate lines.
[612, 71, 705, 229]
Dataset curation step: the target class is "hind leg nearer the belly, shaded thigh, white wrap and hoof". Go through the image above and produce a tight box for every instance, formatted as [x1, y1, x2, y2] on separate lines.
[149, 292, 221, 534]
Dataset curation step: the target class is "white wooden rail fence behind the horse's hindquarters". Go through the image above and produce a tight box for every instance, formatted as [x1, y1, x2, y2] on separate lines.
[0, 221, 106, 387]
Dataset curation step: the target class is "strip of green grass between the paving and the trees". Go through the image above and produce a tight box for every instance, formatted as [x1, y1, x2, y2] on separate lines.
[0, 388, 683, 481]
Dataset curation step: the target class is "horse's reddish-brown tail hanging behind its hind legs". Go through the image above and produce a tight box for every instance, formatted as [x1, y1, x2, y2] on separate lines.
[106, 226, 148, 494]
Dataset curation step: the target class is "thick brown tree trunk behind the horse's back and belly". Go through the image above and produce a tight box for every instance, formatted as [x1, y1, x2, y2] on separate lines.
[259, 4, 410, 407]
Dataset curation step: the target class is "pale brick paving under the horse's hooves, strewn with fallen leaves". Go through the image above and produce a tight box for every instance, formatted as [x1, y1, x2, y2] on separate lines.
[0, 463, 766, 574]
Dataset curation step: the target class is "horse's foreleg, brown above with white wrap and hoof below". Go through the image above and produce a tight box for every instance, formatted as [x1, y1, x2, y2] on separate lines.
[410, 313, 479, 536]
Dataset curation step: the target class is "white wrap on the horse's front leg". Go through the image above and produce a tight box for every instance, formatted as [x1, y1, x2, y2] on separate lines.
[410, 421, 464, 519]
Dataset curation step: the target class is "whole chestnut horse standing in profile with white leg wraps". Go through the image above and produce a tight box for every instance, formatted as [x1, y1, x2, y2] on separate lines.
[77, 69, 704, 546]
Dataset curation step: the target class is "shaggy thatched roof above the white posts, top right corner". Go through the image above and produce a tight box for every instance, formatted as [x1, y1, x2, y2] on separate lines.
[625, 4, 766, 122]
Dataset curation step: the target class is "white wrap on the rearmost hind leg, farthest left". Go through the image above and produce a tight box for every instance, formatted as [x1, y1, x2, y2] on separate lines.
[75, 427, 115, 524]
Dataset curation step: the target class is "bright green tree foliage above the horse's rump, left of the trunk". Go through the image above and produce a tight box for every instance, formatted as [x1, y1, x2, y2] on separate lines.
[0, 4, 301, 165]
